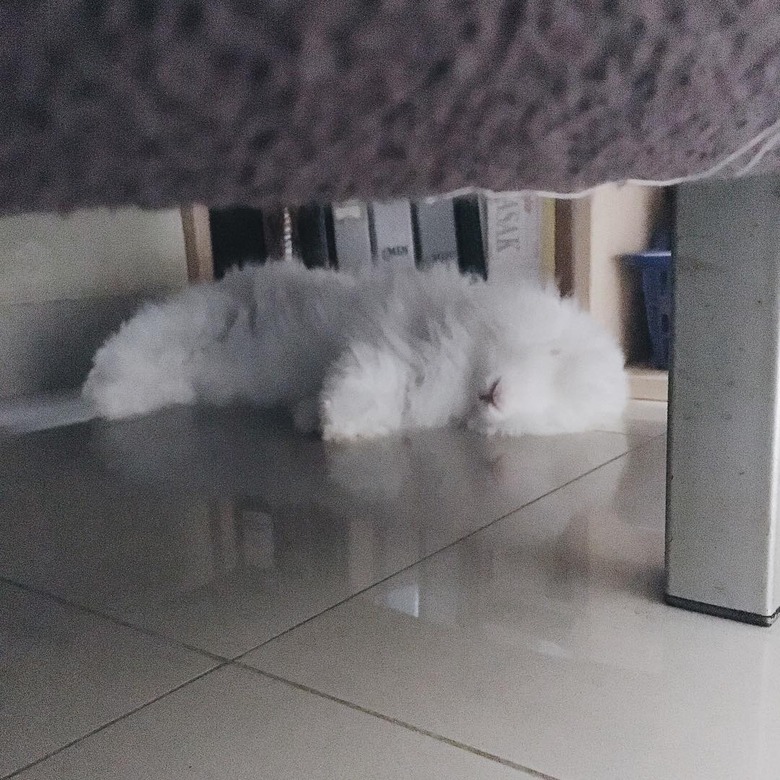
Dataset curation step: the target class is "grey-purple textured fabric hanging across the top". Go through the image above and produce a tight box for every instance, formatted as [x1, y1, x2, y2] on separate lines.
[0, 0, 780, 212]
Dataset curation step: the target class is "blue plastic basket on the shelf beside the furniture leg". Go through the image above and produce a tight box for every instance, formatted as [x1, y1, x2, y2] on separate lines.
[624, 249, 672, 369]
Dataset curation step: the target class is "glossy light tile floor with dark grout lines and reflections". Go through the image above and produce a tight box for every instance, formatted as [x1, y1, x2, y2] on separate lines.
[0, 404, 780, 780]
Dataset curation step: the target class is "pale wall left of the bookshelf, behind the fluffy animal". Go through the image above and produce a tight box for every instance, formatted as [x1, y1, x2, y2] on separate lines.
[0, 209, 187, 397]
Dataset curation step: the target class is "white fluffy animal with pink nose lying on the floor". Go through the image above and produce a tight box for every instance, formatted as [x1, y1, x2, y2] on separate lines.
[84, 263, 626, 439]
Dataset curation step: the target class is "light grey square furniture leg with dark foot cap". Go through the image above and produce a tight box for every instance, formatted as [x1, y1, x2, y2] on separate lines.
[666, 176, 780, 625]
